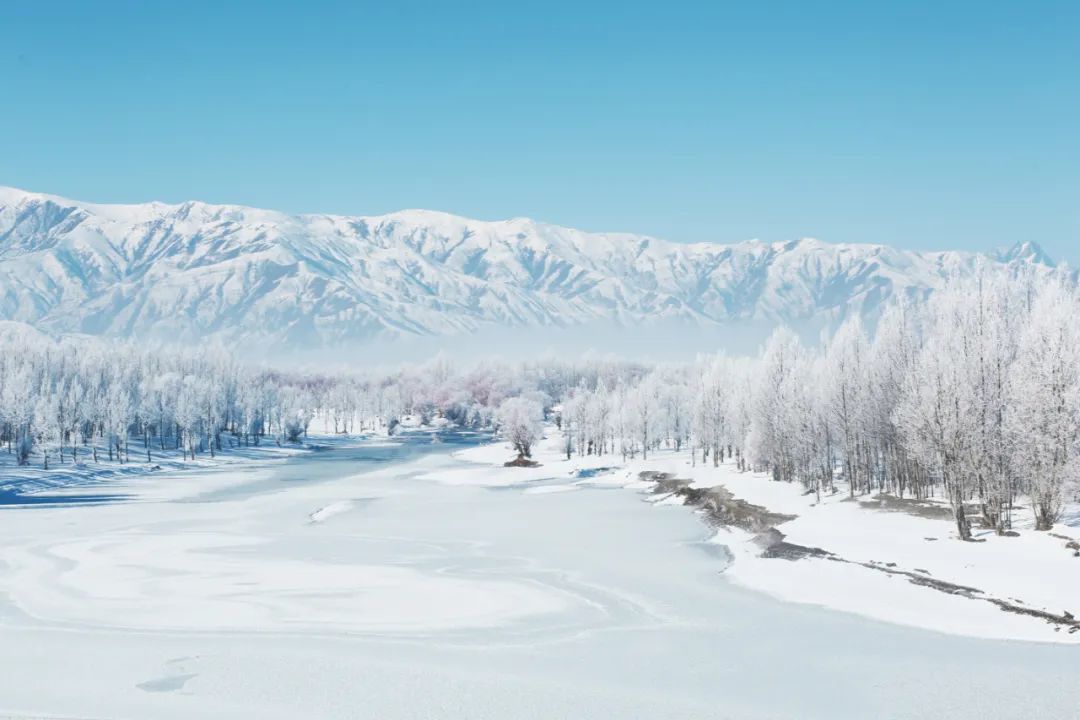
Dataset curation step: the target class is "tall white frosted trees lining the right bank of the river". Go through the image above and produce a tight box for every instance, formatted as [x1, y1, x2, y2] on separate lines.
[559, 274, 1080, 539]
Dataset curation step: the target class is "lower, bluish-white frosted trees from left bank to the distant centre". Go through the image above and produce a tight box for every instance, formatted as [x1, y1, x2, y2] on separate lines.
[0, 331, 635, 468]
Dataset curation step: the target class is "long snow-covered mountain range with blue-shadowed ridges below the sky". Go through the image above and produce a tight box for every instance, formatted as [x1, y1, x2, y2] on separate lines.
[0, 188, 1053, 348]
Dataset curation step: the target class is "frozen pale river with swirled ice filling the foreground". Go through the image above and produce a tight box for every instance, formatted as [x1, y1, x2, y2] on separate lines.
[0, 436, 1080, 720]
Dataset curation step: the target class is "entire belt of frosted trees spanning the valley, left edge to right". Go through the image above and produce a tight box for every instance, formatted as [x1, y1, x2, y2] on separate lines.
[0, 273, 1080, 538]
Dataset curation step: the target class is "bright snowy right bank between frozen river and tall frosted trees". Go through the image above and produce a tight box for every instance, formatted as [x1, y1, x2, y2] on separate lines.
[438, 429, 1080, 643]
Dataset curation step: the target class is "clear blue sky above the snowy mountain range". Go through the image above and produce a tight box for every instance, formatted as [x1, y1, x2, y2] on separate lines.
[0, 0, 1080, 263]
